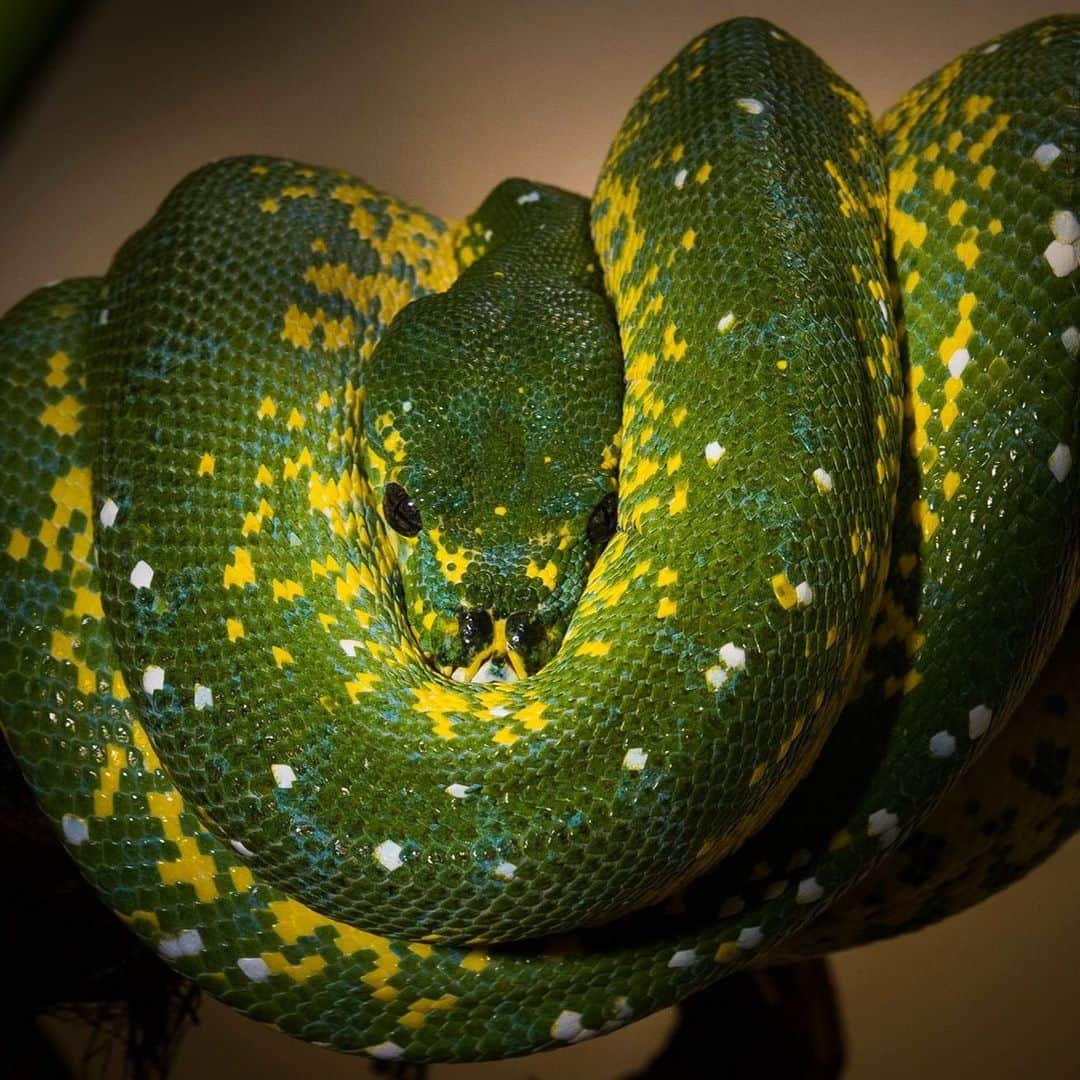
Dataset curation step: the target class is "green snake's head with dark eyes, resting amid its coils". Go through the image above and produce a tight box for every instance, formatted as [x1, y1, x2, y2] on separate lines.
[363, 270, 622, 681]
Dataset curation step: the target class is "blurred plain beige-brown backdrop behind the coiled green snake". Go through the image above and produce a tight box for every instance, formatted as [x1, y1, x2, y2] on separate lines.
[0, 0, 1080, 1080]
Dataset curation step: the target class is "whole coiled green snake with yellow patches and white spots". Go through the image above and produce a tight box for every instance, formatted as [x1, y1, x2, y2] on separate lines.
[0, 16, 1080, 1062]
